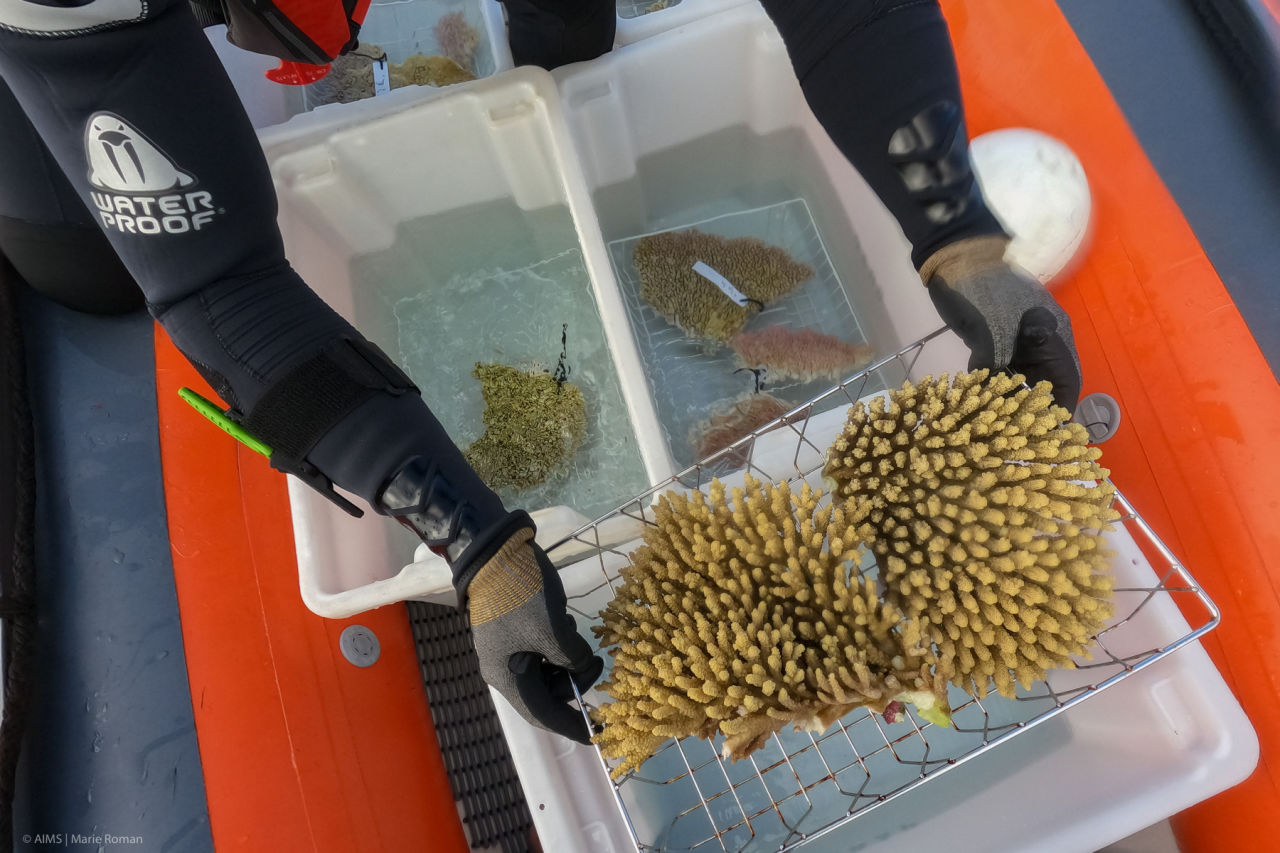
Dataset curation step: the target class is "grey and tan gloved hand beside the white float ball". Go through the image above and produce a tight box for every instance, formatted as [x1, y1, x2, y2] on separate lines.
[920, 236, 1082, 412]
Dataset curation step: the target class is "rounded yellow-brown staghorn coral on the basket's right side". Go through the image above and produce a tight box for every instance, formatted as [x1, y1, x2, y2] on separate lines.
[823, 370, 1117, 697]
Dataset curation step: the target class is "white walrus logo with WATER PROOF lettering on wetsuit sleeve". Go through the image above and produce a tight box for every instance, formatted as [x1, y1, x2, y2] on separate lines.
[84, 113, 218, 236]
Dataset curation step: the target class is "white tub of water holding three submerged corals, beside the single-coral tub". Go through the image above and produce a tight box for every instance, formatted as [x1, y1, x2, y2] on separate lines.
[556, 4, 965, 473]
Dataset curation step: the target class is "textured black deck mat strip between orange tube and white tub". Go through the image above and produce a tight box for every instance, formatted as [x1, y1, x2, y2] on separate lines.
[408, 602, 534, 853]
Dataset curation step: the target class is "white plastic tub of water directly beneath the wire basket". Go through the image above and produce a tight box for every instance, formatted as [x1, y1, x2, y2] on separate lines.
[495, 379, 1258, 853]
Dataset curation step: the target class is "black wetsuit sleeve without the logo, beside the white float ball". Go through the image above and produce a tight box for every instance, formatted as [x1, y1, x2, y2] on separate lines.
[760, 0, 1002, 268]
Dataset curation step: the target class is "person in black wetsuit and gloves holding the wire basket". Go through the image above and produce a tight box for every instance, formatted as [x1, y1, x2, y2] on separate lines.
[0, 0, 1080, 742]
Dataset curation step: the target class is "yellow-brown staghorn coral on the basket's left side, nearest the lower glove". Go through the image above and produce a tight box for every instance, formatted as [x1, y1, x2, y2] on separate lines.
[594, 476, 946, 777]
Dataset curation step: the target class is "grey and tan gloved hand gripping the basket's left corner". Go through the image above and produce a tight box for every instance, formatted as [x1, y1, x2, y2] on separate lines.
[466, 528, 604, 743]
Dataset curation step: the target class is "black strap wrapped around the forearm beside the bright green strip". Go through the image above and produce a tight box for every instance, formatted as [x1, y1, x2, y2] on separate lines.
[239, 338, 417, 462]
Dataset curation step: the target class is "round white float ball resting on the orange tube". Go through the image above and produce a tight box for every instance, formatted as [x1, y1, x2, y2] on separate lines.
[970, 128, 1093, 284]
